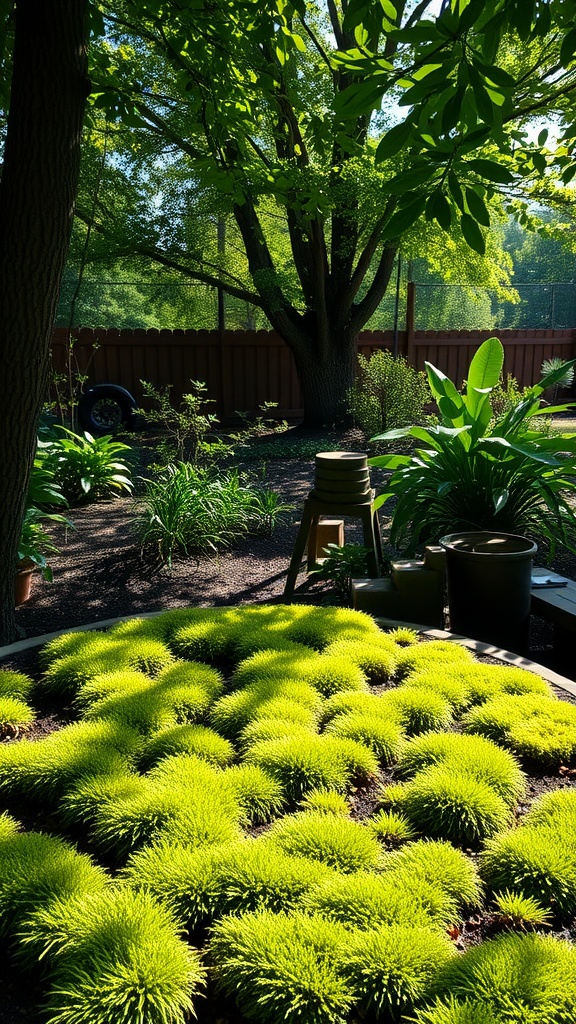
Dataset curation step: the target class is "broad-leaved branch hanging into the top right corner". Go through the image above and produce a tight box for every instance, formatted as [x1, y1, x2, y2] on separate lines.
[334, 0, 576, 253]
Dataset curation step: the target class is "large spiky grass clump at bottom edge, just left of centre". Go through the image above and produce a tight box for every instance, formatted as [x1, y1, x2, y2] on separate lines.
[208, 910, 354, 1024]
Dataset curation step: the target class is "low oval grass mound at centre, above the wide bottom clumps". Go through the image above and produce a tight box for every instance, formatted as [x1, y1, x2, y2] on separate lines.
[266, 811, 380, 872]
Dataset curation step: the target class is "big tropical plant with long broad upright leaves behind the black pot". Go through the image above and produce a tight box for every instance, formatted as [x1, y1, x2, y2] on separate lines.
[370, 338, 576, 553]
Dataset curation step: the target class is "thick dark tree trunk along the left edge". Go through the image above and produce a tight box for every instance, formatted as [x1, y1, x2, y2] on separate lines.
[0, 0, 88, 644]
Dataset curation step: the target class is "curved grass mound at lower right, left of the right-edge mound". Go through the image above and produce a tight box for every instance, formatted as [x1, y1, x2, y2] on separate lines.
[382, 840, 481, 907]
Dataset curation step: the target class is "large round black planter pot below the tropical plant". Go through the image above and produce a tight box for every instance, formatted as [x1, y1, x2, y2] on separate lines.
[440, 531, 538, 654]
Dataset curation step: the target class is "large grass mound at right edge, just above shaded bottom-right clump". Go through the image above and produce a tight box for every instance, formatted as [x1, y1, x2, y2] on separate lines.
[480, 822, 576, 920]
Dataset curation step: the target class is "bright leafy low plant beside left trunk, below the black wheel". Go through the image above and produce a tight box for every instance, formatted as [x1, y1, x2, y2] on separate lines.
[44, 426, 132, 505]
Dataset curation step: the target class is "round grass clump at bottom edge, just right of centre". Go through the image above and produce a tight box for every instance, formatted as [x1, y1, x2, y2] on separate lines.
[343, 924, 455, 1020]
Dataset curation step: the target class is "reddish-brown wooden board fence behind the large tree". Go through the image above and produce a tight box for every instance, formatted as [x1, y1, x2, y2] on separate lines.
[52, 319, 576, 424]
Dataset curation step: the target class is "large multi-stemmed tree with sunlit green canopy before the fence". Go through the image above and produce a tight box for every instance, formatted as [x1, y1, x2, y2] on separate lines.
[72, 0, 576, 425]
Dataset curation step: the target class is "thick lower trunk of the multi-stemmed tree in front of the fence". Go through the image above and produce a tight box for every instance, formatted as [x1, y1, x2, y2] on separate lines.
[291, 334, 358, 428]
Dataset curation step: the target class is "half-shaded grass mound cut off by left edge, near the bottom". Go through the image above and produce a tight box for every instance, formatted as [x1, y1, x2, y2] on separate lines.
[0, 831, 109, 936]
